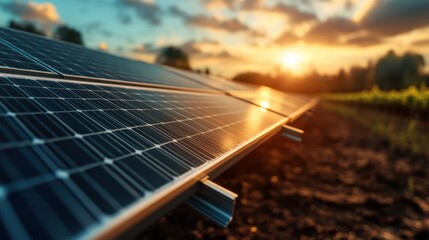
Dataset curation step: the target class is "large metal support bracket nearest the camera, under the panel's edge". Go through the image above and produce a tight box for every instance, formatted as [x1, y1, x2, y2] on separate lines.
[186, 178, 237, 227]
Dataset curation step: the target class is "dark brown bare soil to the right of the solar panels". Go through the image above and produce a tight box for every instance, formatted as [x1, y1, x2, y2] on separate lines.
[139, 102, 429, 239]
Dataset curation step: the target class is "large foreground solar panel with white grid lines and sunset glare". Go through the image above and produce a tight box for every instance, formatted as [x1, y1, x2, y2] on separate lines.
[0, 76, 287, 239]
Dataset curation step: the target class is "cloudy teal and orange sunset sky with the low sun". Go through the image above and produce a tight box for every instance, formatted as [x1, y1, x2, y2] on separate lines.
[0, 0, 429, 77]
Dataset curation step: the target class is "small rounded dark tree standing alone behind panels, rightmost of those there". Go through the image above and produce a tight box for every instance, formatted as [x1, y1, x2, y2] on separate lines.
[155, 46, 192, 70]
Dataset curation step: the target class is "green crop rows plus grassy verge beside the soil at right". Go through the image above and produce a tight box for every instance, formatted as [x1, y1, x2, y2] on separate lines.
[321, 87, 429, 155]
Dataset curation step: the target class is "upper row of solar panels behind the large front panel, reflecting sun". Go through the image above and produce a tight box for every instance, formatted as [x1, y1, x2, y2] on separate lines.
[0, 28, 312, 116]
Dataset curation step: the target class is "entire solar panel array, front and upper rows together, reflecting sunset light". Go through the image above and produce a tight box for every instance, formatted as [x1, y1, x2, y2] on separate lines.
[0, 28, 311, 239]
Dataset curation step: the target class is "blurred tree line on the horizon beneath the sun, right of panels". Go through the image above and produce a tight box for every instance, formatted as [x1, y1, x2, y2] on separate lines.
[233, 50, 429, 93]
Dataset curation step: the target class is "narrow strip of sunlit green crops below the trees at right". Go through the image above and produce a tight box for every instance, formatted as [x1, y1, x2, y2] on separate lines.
[321, 87, 429, 113]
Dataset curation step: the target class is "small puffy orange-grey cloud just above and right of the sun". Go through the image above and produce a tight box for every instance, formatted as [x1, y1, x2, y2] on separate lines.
[304, 18, 359, 45]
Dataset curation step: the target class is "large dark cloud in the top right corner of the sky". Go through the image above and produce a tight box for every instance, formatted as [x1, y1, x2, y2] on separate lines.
[359, 0, 429, 36]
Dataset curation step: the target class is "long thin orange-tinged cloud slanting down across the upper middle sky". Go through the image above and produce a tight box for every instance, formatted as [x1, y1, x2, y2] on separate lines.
[169, 6, 262, 37]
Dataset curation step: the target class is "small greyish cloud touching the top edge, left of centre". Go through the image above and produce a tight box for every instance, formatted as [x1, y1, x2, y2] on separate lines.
[118, 0, 162, 25]
